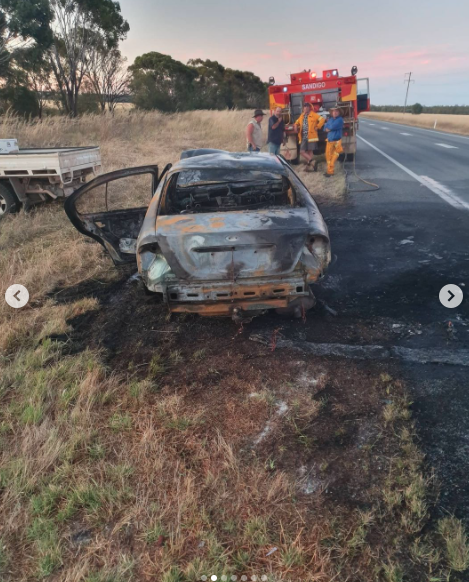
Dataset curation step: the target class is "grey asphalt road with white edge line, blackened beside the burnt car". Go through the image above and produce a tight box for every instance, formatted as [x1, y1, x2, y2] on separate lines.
[307, 120, 469, 525]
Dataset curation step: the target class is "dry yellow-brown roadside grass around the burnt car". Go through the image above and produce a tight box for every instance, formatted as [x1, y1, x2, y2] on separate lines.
[0, 112, 467, 582]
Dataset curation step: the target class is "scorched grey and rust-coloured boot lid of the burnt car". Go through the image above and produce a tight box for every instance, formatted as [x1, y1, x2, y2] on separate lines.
[156, 208, 327, 281]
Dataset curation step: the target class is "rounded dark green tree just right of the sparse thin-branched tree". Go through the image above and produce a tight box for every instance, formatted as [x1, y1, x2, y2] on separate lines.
[129, 52, 197, 111]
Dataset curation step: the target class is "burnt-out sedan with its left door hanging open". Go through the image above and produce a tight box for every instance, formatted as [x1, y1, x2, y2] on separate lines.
[65, 150, 331, 320]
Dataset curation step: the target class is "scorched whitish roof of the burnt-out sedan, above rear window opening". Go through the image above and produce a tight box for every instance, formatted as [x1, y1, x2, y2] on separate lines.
[171, 152, 288, 176]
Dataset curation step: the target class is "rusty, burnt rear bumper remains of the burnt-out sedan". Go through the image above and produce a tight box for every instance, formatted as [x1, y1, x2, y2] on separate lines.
[163, 276, 311, 316]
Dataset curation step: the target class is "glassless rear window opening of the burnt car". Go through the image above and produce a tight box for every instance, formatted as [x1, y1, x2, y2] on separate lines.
[161, 172, 296, 215]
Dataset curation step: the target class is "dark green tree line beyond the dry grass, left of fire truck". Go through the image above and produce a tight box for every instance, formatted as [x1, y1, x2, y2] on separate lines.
[0, 0, 267, 117]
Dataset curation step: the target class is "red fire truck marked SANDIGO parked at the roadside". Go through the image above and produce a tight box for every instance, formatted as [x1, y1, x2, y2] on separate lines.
[269, 67, 370, 164]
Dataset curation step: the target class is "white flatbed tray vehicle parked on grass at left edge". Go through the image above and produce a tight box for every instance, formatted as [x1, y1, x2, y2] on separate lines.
[0, 145, 101, 219]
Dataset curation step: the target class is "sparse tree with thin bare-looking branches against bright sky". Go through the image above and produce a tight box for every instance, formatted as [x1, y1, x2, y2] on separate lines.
[87, 48, 130, 113]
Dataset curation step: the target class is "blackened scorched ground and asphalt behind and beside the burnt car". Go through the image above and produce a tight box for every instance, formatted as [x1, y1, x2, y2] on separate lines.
[45, 149, 469, 580]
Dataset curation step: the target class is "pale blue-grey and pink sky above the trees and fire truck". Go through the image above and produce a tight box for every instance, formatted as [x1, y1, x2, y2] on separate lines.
[119, 0, 469, 105]
